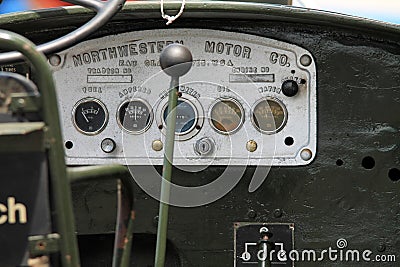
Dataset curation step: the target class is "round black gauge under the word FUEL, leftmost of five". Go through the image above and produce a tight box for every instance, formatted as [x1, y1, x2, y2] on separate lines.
[72, 98, 108, 135]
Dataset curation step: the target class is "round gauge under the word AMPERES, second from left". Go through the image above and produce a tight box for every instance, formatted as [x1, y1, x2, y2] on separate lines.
[117, 99, 153, 134]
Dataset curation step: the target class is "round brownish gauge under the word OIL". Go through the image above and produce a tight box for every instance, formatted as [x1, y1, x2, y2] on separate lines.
[210, 98, 244, 134]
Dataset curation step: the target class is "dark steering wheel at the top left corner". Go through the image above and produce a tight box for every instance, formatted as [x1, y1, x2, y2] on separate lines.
[0, 0, 126, 64]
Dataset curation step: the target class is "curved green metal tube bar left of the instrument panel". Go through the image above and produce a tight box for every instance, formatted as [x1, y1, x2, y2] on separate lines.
[0, 31, 80, 266]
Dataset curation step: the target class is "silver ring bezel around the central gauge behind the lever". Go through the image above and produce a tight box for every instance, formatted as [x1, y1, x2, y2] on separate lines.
[157, 93, 204, 141]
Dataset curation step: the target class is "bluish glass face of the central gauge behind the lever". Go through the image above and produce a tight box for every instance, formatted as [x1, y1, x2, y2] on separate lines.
[163, 100, 197, 135]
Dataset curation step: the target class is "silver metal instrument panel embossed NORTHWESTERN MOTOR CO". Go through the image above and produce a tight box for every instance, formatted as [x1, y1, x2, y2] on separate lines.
[49, 29, 317, 166]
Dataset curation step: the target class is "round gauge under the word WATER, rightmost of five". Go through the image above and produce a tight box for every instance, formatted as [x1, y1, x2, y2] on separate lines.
[251, 99, 287, 134]
